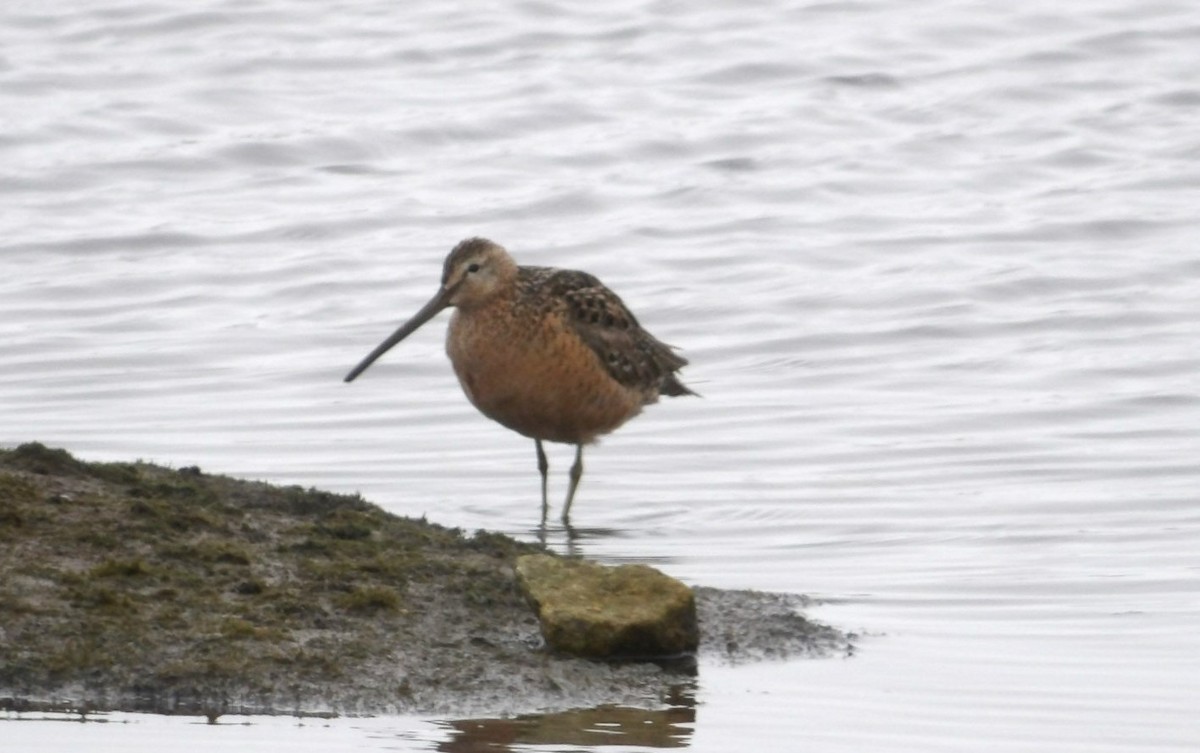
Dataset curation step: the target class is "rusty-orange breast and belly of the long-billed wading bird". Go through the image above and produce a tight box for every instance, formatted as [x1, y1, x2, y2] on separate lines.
[446, 314, 644, 444]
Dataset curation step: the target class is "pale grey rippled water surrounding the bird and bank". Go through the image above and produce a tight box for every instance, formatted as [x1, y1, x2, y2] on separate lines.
[0, 0, 1200, 751]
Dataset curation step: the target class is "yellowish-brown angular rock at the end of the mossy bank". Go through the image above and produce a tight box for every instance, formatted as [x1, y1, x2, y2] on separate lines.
[516, 554, 700, 658]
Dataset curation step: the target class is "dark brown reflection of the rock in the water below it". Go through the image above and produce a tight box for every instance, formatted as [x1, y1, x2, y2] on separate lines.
[437, 691, 696, 753]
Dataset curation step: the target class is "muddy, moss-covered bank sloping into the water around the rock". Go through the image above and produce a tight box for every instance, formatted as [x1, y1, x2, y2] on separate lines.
[0, 444, 850, 716]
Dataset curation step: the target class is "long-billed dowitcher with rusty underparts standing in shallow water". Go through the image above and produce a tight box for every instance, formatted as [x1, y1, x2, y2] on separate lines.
[346, 237, 696, 523]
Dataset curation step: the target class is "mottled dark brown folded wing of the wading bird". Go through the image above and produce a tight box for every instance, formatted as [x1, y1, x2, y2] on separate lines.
[522, 267, 695, 396]
